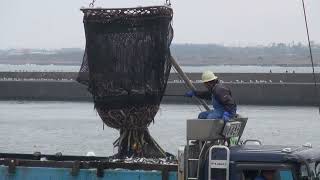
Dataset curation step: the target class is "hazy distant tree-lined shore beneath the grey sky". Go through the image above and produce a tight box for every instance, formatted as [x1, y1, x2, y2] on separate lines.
[0, 43, 320, 67]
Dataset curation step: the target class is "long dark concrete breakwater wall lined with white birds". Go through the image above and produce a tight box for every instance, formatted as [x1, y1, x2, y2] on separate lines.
[0, 72, 320, 105]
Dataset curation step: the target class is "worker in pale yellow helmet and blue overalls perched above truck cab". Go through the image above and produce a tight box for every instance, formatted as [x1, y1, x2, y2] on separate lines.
[185, 71, 237, 121]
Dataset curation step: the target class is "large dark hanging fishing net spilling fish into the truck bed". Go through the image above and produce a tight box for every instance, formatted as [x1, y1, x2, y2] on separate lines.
[77, 6, 173, 158]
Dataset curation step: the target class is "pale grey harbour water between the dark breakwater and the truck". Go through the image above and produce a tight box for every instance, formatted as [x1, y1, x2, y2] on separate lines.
[0, 101, 320, 156]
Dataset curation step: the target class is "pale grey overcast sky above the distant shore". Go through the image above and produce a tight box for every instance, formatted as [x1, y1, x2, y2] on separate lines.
[0, 0, 320, 49]
